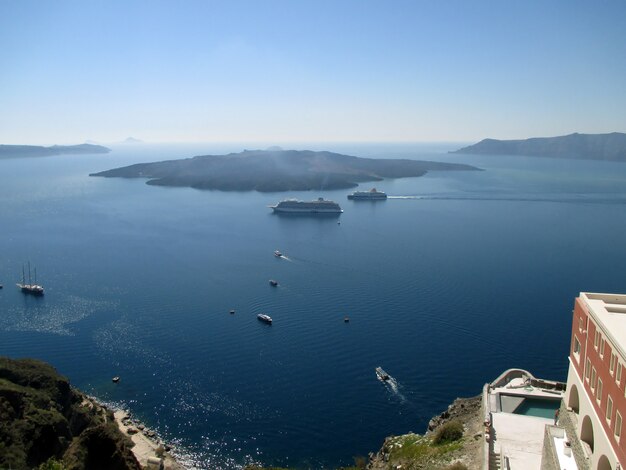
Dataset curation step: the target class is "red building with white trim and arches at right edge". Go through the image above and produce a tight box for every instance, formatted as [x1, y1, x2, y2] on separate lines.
[565, 292, 626, 470]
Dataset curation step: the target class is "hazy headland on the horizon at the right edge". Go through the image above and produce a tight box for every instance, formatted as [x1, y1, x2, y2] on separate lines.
[451, 132, 626, 162]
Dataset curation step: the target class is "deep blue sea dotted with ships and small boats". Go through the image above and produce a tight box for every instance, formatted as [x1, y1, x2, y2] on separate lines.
[0, 143, 626, 469]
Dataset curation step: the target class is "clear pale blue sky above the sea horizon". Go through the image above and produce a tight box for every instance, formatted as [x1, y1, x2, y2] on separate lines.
[0, 0, 626, 144]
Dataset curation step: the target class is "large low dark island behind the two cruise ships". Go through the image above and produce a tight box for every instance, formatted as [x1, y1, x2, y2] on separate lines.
[90, 148, 478, 192]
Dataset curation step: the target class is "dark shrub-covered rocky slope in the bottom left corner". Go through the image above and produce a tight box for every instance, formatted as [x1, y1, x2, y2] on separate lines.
[0, 357, 141, 470]
